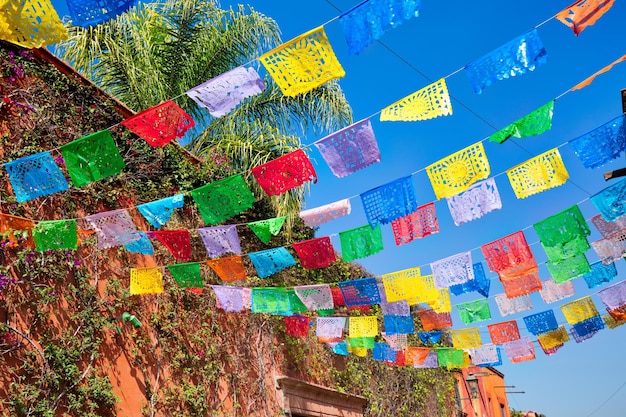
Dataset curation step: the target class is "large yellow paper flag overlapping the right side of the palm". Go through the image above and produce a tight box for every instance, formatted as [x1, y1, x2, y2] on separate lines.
[259, 26, 346, 97]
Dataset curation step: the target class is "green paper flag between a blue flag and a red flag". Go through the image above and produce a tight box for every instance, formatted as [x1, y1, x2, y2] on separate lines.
[61, 130, 125, 187]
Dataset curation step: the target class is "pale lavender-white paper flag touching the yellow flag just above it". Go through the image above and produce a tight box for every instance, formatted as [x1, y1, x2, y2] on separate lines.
[446, 178, 502, 226]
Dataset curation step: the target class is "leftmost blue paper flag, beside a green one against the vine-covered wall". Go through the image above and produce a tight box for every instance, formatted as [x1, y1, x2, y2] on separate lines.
[4, 152, 69, 203]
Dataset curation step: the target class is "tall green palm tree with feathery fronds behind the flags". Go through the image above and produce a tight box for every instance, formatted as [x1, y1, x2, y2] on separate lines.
[55, 0, 352, 224]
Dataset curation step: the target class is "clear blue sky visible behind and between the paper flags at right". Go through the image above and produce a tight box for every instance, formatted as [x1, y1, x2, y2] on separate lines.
[53, 0, 626, 417]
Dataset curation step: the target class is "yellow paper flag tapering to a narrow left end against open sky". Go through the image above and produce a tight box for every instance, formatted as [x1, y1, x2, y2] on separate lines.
[380, 78, 452, 122]
